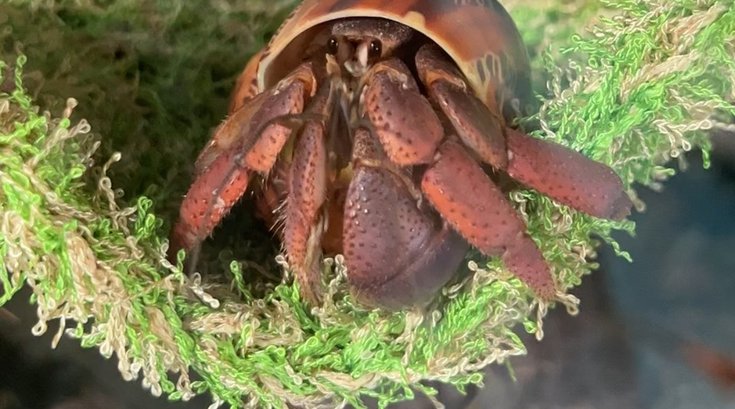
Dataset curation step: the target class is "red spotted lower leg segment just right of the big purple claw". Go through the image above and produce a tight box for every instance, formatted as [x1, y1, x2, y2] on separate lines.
[421, 142, 555, 299]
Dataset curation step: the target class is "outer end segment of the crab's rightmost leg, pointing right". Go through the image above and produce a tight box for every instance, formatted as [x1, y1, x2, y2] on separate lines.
[506, 129, 632, 220]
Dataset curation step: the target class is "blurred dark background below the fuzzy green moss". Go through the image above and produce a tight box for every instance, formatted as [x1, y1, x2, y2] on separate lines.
[0, 132, 735, 409]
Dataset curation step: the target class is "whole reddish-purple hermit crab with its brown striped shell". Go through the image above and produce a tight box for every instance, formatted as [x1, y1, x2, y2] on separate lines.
[171, 0, 631, 309]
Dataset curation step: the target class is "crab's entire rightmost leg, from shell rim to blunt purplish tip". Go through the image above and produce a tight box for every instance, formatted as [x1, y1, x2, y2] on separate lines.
[416, 45, 631, 220]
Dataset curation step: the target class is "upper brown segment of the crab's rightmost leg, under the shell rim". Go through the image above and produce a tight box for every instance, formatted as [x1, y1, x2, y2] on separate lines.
[416, 44, 508, 169]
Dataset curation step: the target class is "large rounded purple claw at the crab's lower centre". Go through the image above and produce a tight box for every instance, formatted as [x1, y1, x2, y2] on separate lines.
[343, 129, 468, 309]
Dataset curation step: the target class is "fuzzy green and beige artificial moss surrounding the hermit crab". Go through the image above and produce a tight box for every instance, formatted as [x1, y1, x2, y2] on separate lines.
[0, 0, 735, 407]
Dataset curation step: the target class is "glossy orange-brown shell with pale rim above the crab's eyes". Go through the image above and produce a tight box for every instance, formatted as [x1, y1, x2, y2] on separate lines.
[257, 0, 530, 116]
